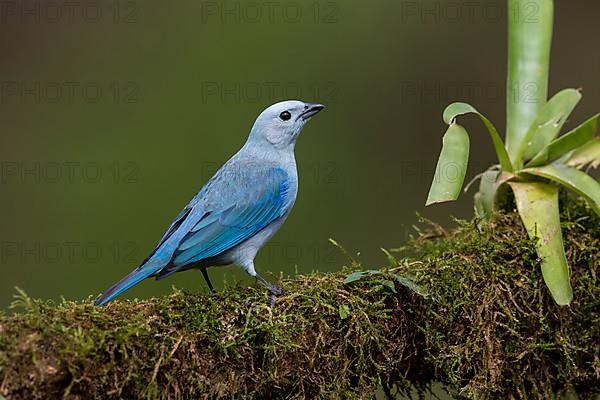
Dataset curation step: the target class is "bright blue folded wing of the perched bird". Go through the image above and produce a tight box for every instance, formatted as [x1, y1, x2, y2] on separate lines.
[160, 168, 293, 276]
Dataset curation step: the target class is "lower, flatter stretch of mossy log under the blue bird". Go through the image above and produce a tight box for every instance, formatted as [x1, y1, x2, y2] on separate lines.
[0, 274, 418, 399]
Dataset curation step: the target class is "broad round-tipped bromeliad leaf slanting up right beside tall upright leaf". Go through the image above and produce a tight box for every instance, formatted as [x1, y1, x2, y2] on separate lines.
[515, 89, 581, 165]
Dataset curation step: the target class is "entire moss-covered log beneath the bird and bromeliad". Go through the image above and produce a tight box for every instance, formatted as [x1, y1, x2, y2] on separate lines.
[0, 195, 600, 399]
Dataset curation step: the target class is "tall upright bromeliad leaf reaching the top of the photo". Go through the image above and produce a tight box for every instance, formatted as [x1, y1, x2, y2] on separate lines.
[506, 0, 553, 162]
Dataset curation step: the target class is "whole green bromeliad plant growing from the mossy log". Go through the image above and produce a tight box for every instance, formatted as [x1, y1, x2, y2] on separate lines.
[427, 0, 600, 305]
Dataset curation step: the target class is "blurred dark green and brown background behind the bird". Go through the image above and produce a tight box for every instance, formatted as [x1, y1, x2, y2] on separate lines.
[0, 0, 600, 309]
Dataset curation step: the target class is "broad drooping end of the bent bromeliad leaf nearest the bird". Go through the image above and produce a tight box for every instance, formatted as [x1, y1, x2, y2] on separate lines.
[425, 124, 469, 206]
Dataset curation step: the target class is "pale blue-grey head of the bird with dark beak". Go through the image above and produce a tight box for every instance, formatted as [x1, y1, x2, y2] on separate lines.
[248, 100, 325, 149]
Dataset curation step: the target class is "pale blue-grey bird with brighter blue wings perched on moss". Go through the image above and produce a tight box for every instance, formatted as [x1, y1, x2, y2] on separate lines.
[95, 100, 325, 307]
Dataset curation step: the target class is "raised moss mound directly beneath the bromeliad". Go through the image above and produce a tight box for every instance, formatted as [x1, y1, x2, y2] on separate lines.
[394, 193, 600, 399]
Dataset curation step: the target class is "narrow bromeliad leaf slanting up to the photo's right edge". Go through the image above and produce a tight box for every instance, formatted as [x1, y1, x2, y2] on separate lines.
[527, 114, 600, 167]
